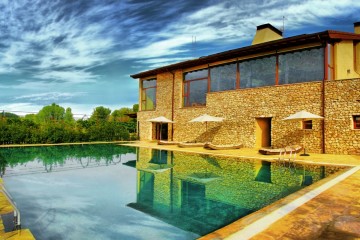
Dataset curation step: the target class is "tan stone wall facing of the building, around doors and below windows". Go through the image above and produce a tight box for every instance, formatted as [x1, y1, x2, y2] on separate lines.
[138, 70, 360, 154]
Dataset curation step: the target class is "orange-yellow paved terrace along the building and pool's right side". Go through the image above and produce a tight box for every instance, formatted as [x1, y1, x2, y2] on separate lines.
[126, 142, 360, 240]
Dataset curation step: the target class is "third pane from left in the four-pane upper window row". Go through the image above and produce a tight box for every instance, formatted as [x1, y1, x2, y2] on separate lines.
[240, 56, 276, 88]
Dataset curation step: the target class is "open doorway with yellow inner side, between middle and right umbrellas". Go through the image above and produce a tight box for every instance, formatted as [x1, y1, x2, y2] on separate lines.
[255, 118, 271, 148]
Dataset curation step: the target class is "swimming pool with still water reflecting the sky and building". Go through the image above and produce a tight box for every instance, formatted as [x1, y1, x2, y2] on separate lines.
[0, 144, 346, 239]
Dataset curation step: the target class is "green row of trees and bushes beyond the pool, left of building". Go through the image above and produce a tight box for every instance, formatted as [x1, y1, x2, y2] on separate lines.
[0, 103, 138, 144]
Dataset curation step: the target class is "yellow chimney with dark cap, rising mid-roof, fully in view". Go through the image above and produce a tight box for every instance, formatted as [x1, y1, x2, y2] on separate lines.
[251, 23, 282, 45]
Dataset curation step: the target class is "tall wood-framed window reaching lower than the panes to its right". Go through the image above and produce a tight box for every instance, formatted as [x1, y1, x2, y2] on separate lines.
[183, 69, 208, 107]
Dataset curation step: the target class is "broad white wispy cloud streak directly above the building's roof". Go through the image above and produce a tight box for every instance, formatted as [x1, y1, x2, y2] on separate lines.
[124, 0, 360, 62]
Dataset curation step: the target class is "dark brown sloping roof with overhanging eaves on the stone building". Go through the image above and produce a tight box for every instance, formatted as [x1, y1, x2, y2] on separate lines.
[131, 30, 360, 78]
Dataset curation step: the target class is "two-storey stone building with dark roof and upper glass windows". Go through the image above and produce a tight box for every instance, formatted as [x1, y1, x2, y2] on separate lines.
[131, 22, 360, 154]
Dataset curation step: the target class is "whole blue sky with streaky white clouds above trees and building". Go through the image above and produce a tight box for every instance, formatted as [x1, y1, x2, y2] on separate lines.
[0, 0, 360, 116]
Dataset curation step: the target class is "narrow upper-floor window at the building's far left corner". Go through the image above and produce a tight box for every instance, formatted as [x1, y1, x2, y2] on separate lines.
[141, 79, 156, 110]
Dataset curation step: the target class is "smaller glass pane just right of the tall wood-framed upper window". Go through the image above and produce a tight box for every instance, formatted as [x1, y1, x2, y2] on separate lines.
[210, 63, 236, 92]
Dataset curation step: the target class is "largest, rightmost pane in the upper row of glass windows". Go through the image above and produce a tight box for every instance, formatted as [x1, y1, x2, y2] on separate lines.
[279, 48, 324, 84]
